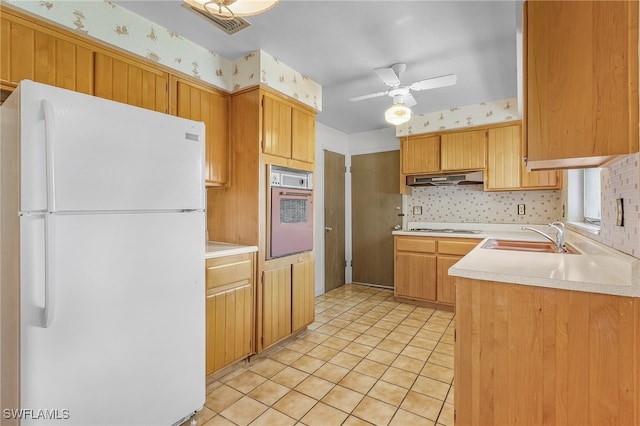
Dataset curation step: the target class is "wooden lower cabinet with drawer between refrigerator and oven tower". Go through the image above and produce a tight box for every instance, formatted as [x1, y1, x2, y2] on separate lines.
[205, 253, 255, 374]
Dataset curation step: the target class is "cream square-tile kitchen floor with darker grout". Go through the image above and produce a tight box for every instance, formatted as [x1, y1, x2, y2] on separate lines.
[197, 284, 455, 426]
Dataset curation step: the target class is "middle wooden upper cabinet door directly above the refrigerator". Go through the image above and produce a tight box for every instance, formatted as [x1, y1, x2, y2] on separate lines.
[94, 52, 169, 113]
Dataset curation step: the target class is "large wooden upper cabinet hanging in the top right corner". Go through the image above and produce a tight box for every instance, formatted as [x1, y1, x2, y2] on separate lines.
[523, 1, 638, 169]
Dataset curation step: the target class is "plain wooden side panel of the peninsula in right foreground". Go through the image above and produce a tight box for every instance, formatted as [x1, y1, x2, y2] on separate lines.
[454, 278, 640, 426]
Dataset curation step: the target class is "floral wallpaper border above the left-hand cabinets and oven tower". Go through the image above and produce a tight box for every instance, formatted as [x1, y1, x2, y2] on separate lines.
[5, 0, 322, 111]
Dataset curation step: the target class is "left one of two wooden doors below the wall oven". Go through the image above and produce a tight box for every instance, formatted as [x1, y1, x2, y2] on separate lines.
[262, 265, 291, 348]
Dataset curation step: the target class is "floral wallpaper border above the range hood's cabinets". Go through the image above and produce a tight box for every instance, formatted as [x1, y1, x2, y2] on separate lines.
[396, 98, 519, 136]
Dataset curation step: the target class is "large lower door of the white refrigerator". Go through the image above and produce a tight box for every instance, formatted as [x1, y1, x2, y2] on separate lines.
[20, 212, 205, 425]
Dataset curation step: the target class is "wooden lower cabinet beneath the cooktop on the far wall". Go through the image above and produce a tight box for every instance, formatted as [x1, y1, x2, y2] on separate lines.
[394, 235, 481, 309]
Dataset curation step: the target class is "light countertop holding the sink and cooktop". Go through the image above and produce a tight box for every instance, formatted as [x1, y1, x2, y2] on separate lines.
[393, 223, 640, 297]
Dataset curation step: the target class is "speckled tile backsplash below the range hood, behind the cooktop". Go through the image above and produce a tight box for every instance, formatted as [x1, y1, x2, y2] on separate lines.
[402, 185, 564, 224]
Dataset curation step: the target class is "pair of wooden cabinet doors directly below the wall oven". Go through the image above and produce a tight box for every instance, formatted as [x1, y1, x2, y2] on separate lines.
[258, 259, 315, 352]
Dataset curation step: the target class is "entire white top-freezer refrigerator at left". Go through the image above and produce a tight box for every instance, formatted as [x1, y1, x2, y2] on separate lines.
[0, 81, 206, 426]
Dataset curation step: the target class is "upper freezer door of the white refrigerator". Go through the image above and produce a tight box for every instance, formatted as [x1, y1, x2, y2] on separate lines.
[20, 81, 205, 211]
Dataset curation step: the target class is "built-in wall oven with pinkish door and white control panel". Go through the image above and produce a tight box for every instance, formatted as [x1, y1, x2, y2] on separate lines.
[267, 165, 313, 259]
